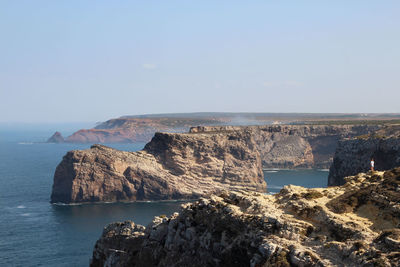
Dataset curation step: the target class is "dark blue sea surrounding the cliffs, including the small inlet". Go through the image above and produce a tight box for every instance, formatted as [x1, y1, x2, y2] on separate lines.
[0, 125, 328, 266]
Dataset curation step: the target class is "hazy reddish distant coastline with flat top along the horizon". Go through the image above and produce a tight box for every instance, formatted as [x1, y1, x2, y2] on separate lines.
[47, 112, 400, 144]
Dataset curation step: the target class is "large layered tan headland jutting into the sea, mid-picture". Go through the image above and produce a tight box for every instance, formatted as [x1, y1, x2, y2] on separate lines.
[51, 131, 266, 203]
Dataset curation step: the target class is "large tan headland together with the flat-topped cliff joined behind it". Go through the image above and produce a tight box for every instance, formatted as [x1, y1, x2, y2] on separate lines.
[51, 125, 379, 203]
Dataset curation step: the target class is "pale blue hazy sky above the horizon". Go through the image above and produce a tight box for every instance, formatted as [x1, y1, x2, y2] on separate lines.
[0, 0, 400, 123]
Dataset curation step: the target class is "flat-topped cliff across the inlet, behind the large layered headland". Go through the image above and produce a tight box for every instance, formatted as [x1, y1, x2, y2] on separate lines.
[190, 125, 383, 168]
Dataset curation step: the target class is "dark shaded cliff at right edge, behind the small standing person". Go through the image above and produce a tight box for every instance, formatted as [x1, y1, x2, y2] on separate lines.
[328, 135, 400, 186]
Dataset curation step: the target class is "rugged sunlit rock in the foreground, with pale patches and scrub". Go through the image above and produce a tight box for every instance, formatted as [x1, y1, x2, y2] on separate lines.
[91, 168, 400, 266]
